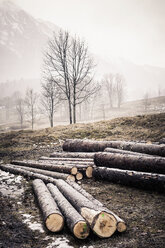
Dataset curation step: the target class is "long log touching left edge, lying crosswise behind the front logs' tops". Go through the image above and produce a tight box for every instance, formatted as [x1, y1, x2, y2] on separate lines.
[0, 164, 73, 183]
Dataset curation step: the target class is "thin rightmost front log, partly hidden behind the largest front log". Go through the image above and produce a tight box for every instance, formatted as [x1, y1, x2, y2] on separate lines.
[67, 180, 127, 232]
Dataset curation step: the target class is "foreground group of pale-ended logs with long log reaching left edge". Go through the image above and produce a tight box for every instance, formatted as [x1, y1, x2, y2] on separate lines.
[0, 164, 126, 239]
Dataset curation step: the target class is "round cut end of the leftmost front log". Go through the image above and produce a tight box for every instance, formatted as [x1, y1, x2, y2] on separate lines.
[45, 214, 64, 232]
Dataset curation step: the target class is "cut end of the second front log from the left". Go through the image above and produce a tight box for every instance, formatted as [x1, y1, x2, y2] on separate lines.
[73, 221, 89, 239]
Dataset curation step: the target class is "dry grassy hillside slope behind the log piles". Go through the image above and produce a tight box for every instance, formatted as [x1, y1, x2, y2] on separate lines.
[0, 113, 165, 159]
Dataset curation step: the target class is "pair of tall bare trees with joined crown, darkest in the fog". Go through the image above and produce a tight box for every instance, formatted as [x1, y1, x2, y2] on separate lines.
[43, 31, 96, 124]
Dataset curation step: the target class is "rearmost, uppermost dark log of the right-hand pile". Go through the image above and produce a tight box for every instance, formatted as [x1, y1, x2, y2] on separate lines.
[63, 139, 165, 157]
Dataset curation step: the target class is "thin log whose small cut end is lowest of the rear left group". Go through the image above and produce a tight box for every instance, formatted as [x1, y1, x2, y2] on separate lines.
[11, 165, 75, 181]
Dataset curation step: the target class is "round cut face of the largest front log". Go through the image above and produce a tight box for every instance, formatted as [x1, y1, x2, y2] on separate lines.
[93, 212, 116, 238]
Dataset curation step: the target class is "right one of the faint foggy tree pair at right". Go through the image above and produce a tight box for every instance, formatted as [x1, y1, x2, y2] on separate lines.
[115, 73, 124, 108]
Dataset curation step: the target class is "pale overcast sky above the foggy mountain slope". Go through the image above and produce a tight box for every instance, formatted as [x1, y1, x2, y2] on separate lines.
[8, 0, 165, 67]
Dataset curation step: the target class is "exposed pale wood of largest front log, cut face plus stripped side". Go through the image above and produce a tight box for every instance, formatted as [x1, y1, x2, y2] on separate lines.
[81, 207, 117, 238]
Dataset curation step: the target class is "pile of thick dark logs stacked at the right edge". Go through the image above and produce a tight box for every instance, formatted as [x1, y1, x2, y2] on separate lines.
[63, 140, 165, 192]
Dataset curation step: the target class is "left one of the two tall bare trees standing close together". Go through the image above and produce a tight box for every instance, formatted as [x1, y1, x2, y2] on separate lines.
[43, 31, 72, 124]
